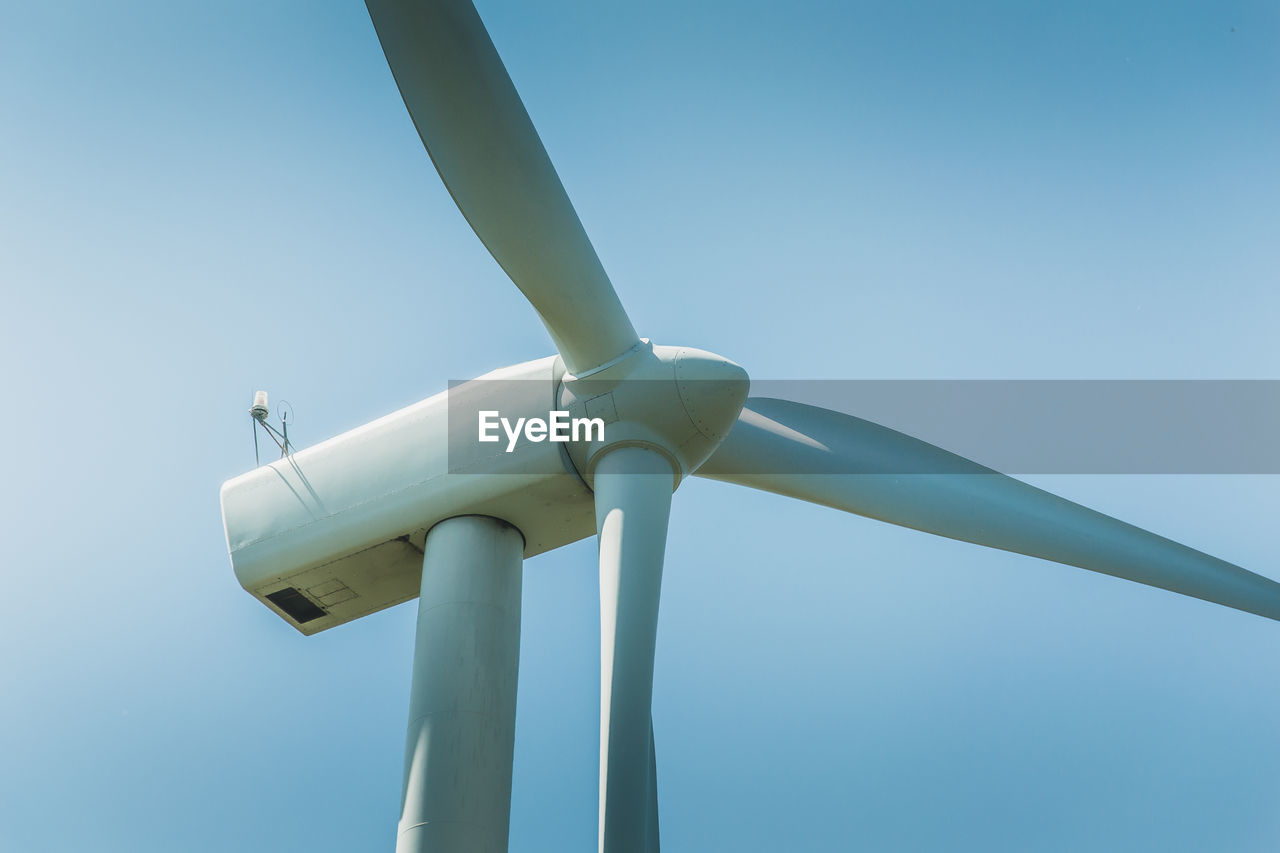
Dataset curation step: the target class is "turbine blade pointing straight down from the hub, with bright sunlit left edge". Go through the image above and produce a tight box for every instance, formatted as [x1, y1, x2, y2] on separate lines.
[594, 447, 673, 853]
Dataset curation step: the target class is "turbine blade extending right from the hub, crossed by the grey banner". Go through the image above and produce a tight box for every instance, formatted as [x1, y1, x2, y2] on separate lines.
[698, 397, 1280, 620]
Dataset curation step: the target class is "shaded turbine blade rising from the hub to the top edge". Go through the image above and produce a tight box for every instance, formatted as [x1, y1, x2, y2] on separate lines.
[366, 0, 637, 374]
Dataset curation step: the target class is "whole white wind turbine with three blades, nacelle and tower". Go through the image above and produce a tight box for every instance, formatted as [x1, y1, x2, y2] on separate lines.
[221, 0, 1280, 853]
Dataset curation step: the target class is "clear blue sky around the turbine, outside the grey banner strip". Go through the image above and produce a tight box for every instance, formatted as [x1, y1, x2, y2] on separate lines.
[0, 0, 1280, 853]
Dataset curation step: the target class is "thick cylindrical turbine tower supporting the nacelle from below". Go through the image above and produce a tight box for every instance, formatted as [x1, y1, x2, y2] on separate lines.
[396, 516, 524, 853]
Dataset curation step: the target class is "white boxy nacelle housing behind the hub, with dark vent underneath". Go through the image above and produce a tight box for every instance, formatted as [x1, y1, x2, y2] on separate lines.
[221, 357, 595, 634]
